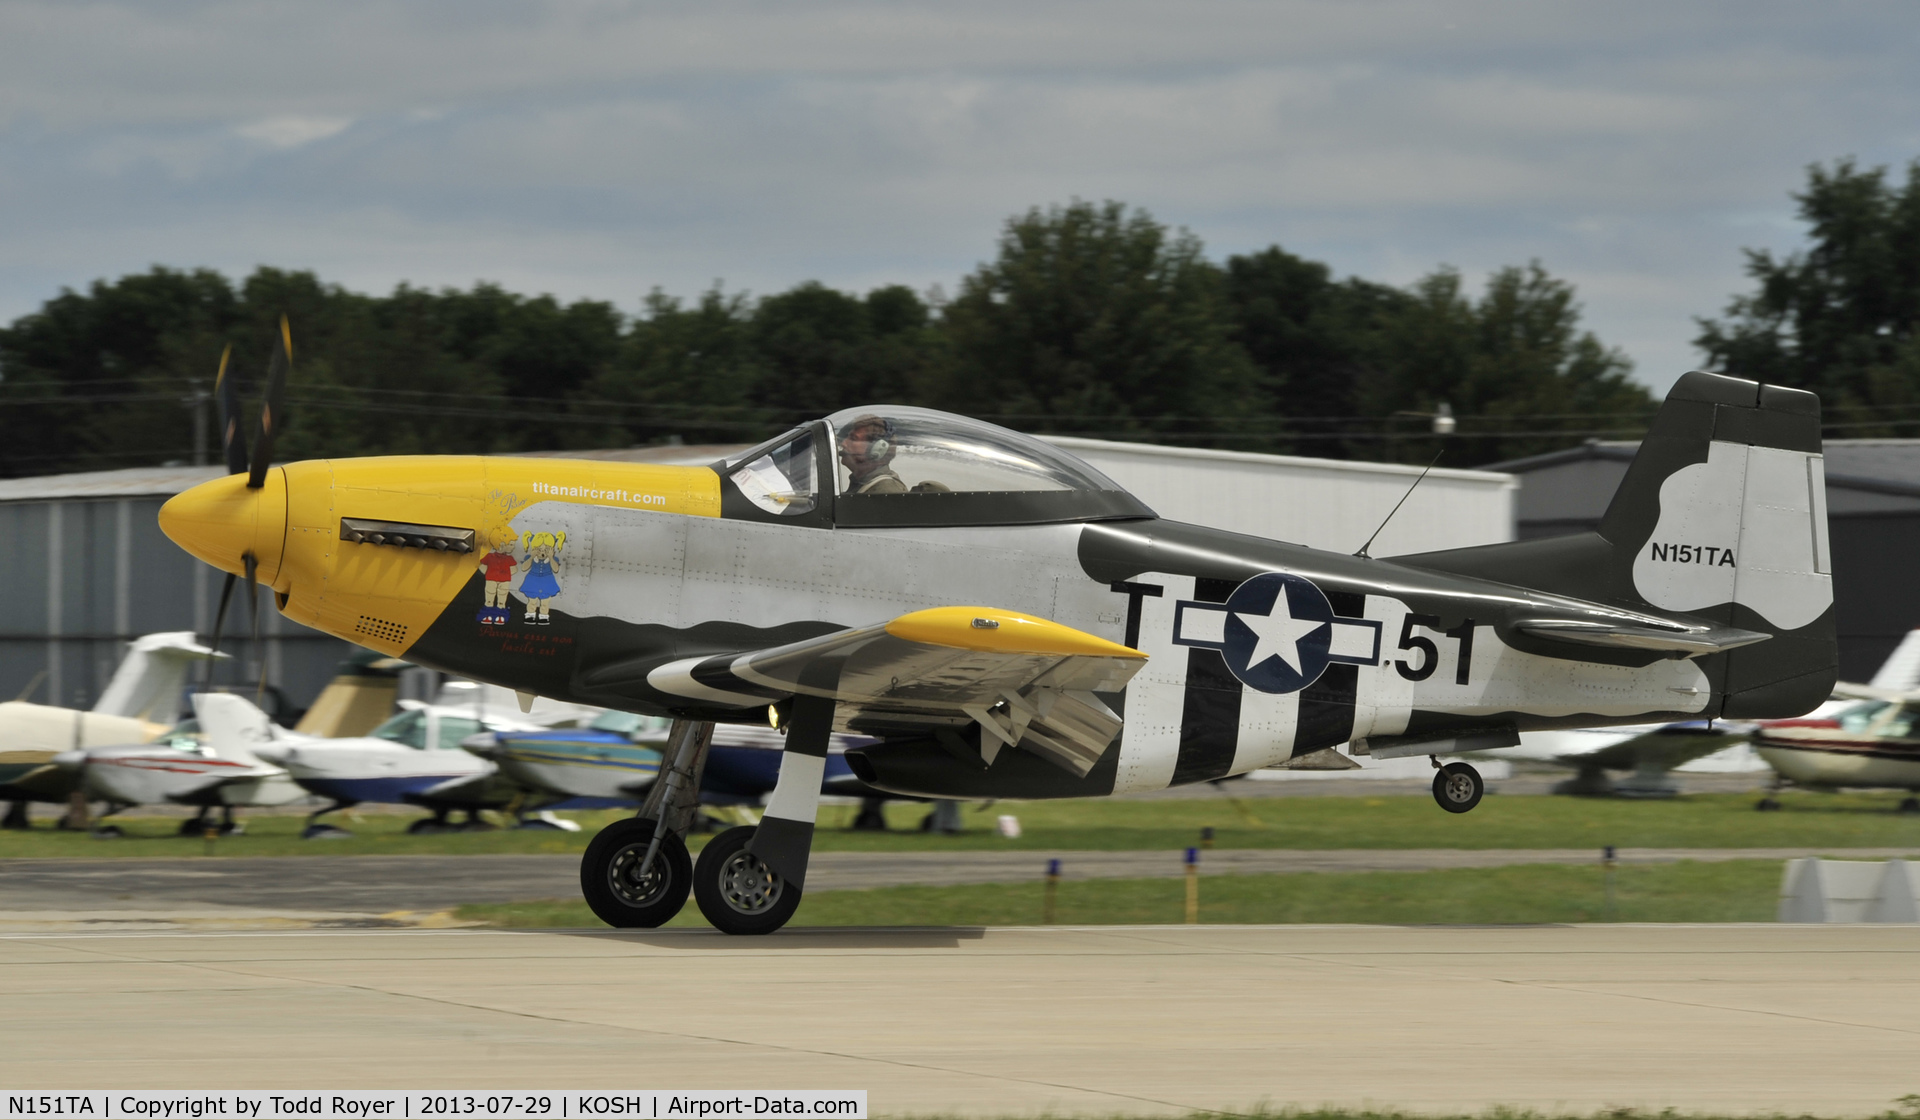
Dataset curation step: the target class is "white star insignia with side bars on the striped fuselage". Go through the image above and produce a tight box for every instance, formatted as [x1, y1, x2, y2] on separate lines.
[1173, 572, 1380, 694]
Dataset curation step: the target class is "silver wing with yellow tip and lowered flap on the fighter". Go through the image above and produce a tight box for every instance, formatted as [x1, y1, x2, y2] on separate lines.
[647, 607, 1146, 774]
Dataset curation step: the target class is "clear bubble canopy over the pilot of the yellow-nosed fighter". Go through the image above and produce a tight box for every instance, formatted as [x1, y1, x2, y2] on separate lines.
[718, 405, 1154, 526]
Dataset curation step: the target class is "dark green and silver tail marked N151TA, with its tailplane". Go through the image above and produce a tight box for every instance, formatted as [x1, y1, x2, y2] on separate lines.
[1396, 373, 1835, 718]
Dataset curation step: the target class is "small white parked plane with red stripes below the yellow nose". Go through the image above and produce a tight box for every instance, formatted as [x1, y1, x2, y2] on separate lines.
[54, 692, 305, 836]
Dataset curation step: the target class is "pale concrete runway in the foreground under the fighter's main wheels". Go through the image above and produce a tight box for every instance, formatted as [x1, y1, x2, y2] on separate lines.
[0, 926, 1920, 1116]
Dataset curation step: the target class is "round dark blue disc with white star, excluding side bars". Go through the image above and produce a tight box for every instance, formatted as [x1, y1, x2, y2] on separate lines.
[1221, 572, 1332, 692]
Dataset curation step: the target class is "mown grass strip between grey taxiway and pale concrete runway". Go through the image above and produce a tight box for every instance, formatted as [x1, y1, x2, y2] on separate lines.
[455, 861, 1780, 928]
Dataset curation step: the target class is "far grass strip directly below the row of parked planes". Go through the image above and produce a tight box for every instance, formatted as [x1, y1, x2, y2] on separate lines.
[11, 786, 1920, 859]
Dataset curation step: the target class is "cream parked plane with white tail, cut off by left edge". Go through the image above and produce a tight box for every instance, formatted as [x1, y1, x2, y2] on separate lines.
[0, 630, 225, 828]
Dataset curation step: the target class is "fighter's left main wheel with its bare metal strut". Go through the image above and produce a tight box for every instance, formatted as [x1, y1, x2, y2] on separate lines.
[580, 720, 714, 930]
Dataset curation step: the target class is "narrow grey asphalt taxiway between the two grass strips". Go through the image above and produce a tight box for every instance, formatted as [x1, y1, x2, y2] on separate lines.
[0, 847, 1920, 928]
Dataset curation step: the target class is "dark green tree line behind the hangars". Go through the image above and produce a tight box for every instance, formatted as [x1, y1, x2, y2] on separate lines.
[0, 161, 1920, 476]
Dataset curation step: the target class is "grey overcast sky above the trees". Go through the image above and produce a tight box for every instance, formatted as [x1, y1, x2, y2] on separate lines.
[0, 0, 1920, 388]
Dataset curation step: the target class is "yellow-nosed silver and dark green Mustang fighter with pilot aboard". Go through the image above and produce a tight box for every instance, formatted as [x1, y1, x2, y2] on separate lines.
[159, 330, 1836, 934]
